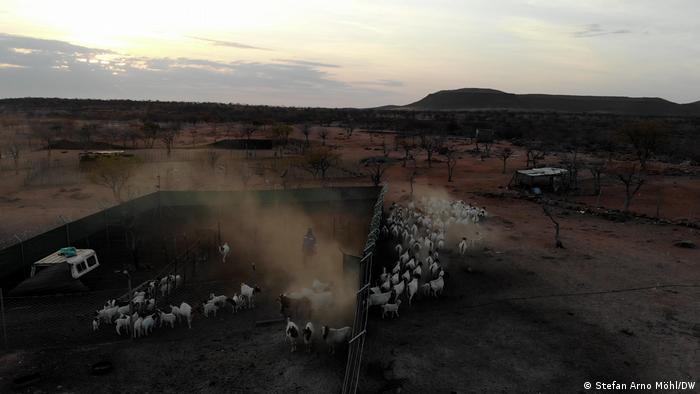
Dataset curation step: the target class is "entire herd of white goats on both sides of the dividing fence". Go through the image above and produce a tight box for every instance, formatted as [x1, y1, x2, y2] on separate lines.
[92, 198, 487, 353]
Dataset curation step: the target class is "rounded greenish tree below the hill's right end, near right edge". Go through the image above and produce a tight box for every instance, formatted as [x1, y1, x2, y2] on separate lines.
[620, 120, 669, 171]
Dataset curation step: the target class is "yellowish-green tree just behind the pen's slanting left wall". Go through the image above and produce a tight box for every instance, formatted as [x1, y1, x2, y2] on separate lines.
[89, 156, 140, 203]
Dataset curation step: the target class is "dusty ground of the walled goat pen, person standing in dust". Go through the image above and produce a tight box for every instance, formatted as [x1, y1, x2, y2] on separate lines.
[0, 187, 379, 392]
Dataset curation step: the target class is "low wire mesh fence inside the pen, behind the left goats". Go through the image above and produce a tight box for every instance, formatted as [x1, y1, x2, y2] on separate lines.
[0, 232, 213, 349]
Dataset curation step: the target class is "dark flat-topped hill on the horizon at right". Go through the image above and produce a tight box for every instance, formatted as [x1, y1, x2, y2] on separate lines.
[394, 88, 700, 116]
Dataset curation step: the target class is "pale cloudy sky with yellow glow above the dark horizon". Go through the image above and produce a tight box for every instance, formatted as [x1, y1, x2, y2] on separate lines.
[0, 0, 700, 108]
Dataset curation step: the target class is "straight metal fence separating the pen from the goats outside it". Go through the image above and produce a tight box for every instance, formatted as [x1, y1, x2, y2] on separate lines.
[341, 186, 386, 394]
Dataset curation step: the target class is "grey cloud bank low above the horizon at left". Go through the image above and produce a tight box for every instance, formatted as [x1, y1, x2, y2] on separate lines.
[0, 34, 396, 107]
